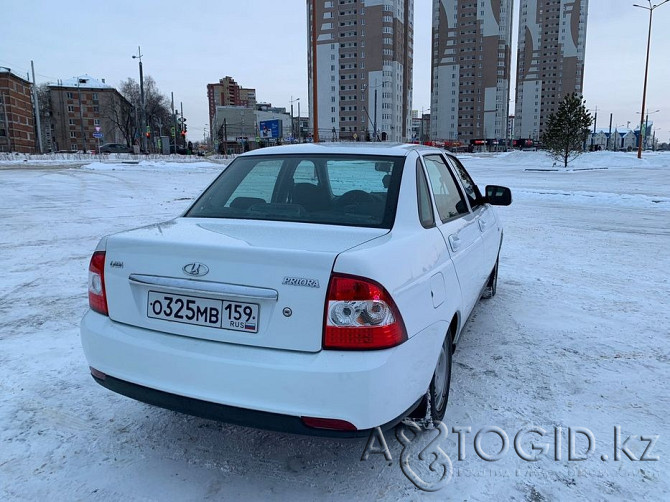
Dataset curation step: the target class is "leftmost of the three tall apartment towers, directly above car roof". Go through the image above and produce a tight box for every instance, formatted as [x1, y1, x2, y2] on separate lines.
[307, 0, 414, 141]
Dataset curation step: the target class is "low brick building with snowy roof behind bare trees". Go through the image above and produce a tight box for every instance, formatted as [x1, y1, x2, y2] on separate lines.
[46, 75, 132, 152]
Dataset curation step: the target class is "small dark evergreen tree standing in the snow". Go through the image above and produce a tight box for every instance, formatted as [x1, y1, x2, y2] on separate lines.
[542, 92, 593, 167]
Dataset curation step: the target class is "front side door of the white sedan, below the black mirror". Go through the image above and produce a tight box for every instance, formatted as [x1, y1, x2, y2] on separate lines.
[448, 157, 500, 281]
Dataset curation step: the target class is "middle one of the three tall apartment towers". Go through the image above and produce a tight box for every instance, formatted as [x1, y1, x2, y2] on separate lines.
[430, 0, 513, 143]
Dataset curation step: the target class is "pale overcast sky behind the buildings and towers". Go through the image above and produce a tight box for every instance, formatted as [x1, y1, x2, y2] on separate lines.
[0, 0, 670, 141]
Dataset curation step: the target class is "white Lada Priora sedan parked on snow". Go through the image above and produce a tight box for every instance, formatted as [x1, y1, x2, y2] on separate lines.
[81, 143, 511, 436]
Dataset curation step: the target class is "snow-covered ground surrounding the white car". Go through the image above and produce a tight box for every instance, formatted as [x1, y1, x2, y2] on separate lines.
[0, 152, 670, 502]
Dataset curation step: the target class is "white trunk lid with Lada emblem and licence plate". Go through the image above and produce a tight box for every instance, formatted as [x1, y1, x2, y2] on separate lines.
[105, 218, 388, 352]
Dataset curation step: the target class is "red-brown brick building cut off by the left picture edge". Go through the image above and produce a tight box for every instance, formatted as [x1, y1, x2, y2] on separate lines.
[0, 67, 37, 153]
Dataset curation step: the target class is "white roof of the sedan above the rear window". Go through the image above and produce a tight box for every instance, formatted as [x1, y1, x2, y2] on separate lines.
[241, 141, 445, 157]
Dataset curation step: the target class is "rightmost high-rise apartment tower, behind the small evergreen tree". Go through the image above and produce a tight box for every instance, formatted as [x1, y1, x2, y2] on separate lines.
[514, 0, 589, 140]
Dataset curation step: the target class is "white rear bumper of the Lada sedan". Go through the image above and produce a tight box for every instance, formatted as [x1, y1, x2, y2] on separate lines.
[81, 311, 447, 436]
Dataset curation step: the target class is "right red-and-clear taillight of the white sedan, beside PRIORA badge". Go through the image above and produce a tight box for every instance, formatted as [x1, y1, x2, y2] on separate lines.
[323, 274, 407, 350]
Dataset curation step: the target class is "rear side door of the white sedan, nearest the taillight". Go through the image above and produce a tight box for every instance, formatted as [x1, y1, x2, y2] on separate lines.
[422, 153, 484, 316]
